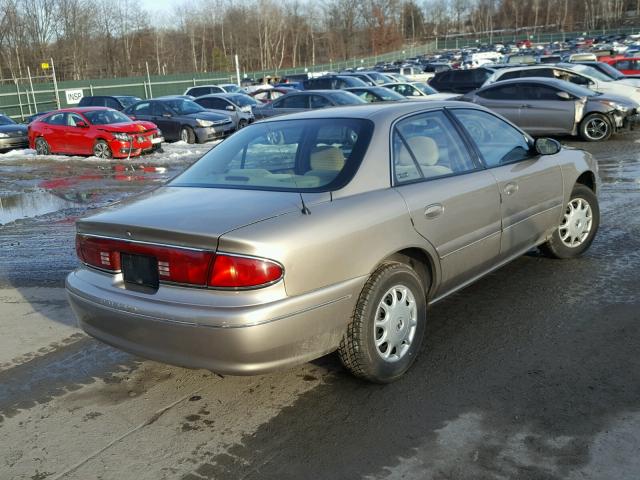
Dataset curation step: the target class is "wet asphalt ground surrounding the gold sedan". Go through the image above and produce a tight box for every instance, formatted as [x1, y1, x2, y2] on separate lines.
[0, 134, 640, 480]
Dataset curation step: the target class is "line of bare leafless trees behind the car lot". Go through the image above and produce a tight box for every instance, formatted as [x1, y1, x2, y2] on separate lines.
[0, 0, 640, 80]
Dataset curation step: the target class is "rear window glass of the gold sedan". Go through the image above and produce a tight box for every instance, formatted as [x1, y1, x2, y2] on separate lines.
[170, 118, 373, 192]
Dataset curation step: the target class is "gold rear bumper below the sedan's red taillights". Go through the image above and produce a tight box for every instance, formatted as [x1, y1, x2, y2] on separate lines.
[66, 268, 366, 375]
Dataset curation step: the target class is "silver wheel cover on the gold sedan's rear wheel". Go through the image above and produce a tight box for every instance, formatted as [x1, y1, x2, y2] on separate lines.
[373, 285, 418, 362]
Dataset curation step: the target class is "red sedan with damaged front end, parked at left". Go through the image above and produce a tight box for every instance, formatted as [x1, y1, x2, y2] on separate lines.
[28, 107, 164, 158]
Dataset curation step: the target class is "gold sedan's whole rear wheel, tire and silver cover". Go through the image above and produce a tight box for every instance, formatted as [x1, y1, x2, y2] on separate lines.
[338, 263, 427, 383]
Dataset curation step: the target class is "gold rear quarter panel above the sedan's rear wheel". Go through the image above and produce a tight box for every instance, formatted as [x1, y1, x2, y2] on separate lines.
[218, 188, 439, 296]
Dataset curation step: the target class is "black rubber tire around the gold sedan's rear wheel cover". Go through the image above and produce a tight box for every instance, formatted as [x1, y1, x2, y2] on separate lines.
[338, 263, 428, 383]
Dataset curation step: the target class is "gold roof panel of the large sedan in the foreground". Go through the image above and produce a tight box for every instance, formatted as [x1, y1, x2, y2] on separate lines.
[260, 100, 486, 123]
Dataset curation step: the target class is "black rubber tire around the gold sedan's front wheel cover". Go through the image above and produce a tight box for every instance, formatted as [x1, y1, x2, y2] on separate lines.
[539, 184, 600, 258]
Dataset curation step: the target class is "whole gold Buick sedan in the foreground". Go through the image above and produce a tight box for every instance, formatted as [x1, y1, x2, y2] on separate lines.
[66, 101, 599, 382]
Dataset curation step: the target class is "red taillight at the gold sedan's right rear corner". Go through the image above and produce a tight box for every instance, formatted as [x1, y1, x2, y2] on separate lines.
[208, 253, 283, 288]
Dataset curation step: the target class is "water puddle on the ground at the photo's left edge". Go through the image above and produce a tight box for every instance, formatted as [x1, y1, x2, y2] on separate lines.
[0, 192, 77, 225]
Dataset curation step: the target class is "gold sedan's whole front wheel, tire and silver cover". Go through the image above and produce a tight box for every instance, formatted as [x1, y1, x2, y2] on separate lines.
[540, 185, 600, 258]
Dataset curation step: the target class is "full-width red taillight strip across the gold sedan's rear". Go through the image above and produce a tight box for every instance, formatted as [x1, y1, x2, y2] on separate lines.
[76, 234, 284, 289]
